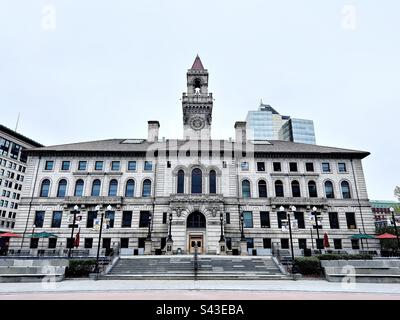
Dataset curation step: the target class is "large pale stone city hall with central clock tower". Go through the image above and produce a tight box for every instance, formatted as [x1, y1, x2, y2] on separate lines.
[11, 56, 378, 254]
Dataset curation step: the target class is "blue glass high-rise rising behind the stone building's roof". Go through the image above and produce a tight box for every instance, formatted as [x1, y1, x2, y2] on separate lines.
[246, 102, 316, 144]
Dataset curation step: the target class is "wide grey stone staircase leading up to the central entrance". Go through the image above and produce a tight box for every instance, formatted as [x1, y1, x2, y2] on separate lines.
[102, 255, 290, 280]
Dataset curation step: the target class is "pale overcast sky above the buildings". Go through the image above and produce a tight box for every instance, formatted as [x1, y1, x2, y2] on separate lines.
[0, 0, 400, 200]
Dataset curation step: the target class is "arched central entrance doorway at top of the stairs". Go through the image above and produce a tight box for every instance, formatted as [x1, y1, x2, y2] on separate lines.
[186, 211, 206, 253]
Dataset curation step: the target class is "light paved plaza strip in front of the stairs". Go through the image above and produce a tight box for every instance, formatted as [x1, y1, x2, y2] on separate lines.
[0, 280, 400, 300]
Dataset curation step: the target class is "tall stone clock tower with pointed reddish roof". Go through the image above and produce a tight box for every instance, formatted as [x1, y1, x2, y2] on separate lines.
[182, 55, 213, 140]
